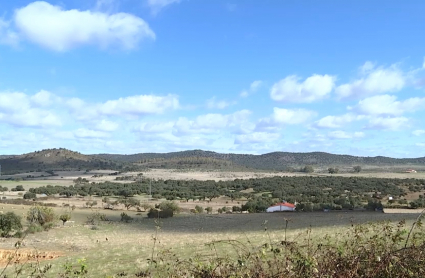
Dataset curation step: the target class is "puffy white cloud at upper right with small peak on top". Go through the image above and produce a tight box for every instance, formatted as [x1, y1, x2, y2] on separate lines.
[335, 62, 406, 99]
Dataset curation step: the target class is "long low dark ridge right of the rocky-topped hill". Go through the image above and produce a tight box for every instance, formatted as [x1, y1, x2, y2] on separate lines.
[95, 150, 425, 170]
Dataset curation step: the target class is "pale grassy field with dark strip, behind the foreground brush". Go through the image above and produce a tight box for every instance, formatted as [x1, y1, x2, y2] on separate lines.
[0, 205, 417, 277]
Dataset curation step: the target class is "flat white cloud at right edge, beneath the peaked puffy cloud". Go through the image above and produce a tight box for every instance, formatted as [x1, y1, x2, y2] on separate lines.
[353, 95, 425, 116]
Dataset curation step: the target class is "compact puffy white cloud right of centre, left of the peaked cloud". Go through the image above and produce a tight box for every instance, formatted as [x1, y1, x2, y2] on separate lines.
[270, 74, 336, 103]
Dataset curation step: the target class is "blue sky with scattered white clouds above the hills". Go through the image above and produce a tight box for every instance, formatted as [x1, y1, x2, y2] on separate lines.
[0, 0, 425, 157]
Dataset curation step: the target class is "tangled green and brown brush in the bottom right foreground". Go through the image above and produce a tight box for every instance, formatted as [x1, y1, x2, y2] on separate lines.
[143, 217, 425, 278]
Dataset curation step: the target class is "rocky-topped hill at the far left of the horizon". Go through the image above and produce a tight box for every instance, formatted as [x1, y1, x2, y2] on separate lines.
[0, 148, 128, 174]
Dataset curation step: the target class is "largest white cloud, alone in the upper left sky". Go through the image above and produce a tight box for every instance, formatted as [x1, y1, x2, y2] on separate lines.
[14, 1, 155, 51]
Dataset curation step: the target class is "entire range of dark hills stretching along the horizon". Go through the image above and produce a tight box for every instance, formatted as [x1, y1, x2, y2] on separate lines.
[0, 148, 425, 174]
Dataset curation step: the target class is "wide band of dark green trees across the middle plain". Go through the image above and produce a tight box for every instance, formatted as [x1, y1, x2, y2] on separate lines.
[29, 176, 425, 211]
